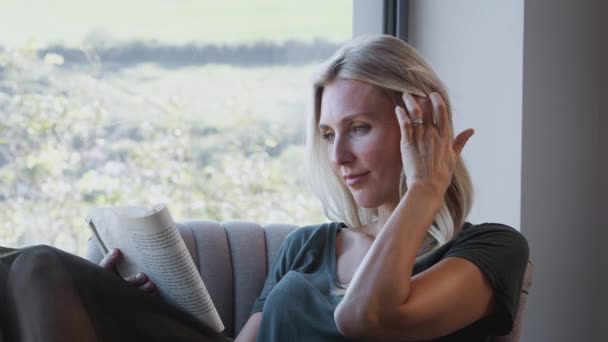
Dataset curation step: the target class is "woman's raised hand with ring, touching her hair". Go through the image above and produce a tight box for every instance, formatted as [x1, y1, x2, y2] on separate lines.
[395, 93, 475, 197]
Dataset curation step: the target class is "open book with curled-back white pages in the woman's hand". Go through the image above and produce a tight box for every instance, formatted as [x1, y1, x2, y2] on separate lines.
[87, 204, 224, 332]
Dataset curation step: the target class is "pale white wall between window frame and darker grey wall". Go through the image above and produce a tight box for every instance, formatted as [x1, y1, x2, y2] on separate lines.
[410, 0, 524, 229]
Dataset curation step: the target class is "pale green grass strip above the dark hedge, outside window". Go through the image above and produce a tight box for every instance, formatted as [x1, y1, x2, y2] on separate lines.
[0, 0, 352, 47]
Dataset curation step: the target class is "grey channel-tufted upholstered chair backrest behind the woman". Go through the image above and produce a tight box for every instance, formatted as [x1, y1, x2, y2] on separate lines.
[85, 221, 532, 342]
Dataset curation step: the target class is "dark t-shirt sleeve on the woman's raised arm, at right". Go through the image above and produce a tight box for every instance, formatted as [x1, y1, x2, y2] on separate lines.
[445, 223, 529, 336]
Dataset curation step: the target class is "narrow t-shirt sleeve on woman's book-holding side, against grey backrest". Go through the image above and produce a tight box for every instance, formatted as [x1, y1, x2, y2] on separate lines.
[249, 228, 304, 316]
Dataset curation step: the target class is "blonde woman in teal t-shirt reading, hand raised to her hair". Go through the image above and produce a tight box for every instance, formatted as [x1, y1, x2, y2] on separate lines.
[0, 36, 528, 341]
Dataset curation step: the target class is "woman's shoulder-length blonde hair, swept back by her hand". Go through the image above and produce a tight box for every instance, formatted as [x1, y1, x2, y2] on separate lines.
[306, 35, 473, 258]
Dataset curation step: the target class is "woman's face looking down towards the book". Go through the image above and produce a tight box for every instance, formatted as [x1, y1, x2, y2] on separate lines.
[319, 79, 402, 208]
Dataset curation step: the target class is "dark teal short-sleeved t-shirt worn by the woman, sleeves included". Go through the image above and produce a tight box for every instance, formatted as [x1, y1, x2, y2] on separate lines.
[251, 222, 529, 342]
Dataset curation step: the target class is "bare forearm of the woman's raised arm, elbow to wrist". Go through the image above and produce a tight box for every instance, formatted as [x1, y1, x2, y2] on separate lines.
[336, 187, 441, 321]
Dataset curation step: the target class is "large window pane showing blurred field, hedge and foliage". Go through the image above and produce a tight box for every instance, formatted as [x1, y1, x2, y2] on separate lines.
[0, 0, 352, 254]
